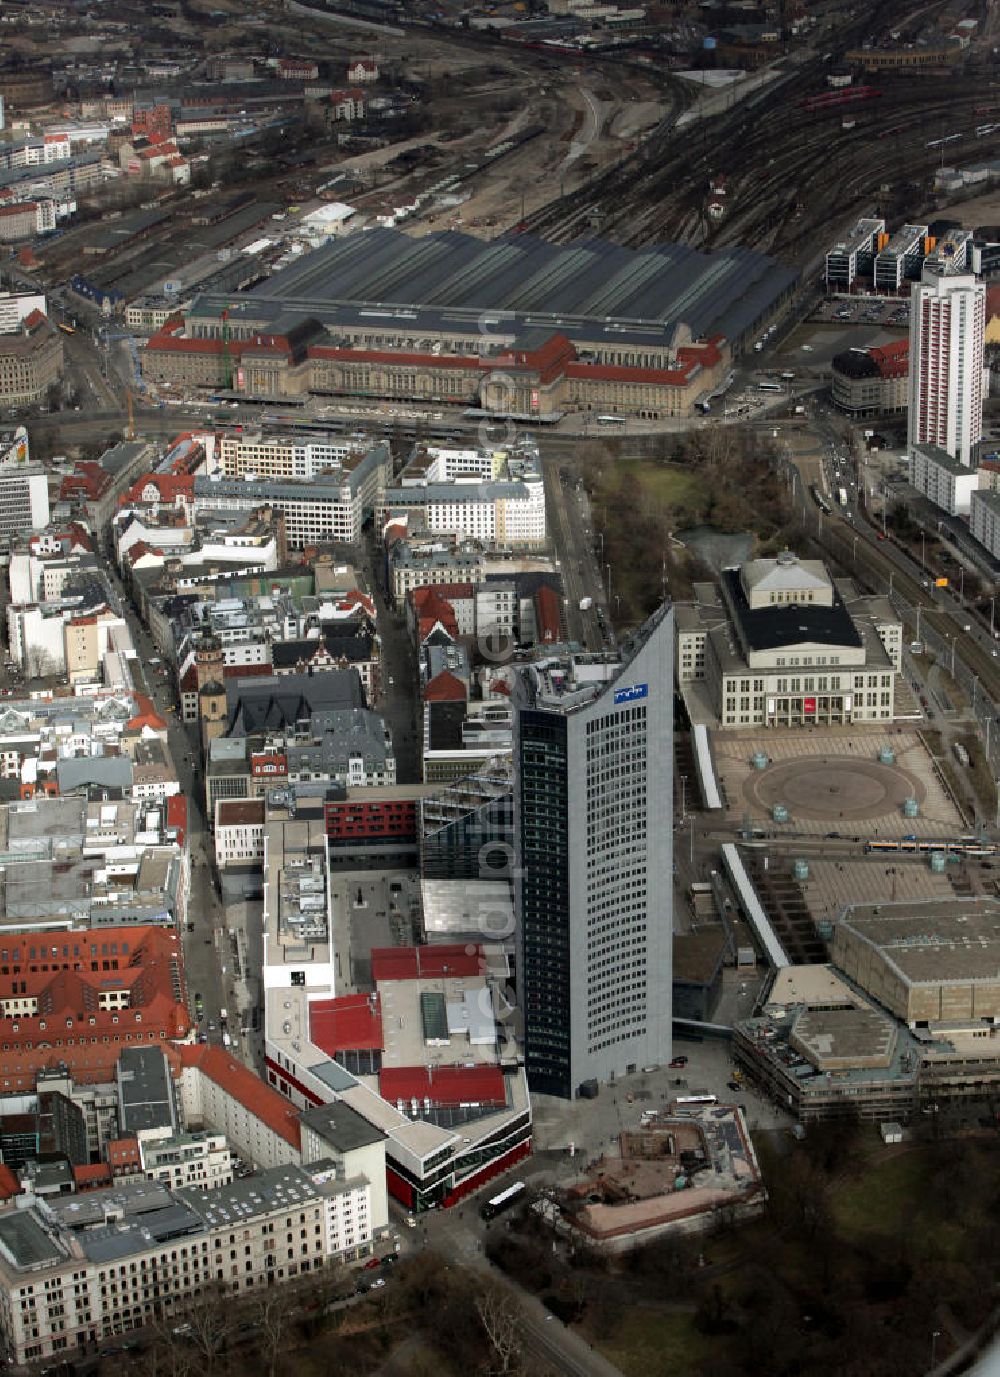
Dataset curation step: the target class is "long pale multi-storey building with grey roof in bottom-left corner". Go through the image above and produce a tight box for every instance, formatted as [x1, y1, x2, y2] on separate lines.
[0, 1162, 372, 1363]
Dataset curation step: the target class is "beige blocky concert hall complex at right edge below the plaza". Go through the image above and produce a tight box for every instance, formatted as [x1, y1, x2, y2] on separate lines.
[734, 898, 1000, 1122]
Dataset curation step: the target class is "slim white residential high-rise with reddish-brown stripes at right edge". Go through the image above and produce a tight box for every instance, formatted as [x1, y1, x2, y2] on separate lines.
[909, 251, 986, 464]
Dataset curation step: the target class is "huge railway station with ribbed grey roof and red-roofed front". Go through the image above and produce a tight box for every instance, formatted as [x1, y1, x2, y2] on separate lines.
[143, 229, 796, 420]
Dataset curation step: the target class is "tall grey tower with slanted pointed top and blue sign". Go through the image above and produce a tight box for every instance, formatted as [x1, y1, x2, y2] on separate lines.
[514, 607, 674, 1099]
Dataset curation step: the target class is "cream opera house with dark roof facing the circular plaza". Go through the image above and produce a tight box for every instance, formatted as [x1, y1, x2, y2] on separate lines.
[675, 551, 902, 727]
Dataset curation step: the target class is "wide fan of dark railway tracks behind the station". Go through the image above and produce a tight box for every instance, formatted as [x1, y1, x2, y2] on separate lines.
[523, 4, 1000, 259]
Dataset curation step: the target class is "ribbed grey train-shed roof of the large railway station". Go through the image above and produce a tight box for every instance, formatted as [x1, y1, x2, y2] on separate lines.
[191, 230, 795, 346]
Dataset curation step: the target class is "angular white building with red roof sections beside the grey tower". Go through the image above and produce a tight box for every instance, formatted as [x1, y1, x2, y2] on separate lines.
[263, 821, 532, 1210]
